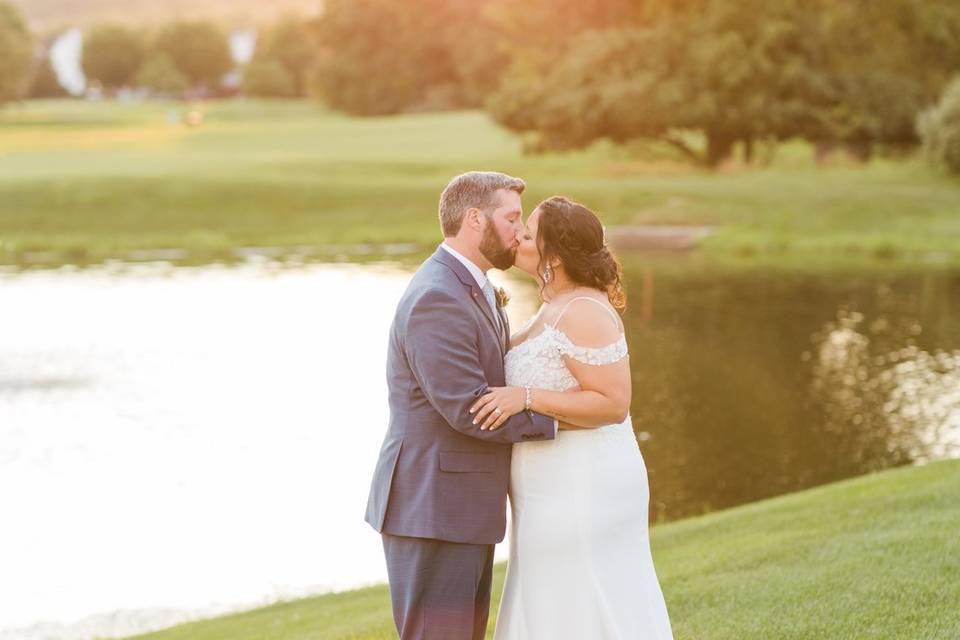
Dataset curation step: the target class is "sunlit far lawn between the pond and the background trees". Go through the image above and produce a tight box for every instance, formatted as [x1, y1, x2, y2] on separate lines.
[0, 101, 960, 264]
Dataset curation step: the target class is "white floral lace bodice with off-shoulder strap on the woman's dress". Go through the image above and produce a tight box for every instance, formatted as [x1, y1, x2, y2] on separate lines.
[504, 324, 627, 391]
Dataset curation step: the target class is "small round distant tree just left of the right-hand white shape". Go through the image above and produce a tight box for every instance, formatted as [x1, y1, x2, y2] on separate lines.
[156, 21, 233, 89]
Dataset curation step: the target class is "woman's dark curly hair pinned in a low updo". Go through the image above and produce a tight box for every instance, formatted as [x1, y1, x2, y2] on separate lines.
[537, 196, 627, 311]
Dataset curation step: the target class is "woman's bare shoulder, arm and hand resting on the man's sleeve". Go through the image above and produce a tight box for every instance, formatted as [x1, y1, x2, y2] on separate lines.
[471, 301, 631, 430]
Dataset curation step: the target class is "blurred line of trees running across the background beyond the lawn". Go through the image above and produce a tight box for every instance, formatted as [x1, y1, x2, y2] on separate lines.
[0, 0, 960, 172]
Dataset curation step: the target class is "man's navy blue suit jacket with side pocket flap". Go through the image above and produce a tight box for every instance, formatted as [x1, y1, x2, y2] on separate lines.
[366, 248, 555, 544]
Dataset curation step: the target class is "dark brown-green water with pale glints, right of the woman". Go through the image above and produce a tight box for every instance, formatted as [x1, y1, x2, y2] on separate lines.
[628, 265, 960, 520]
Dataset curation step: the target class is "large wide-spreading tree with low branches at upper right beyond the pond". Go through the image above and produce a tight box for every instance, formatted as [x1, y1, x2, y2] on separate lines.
[487, 0, 960, 166]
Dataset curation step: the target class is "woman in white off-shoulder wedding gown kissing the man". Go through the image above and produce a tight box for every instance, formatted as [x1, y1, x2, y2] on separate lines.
[471, 196, 672, 640]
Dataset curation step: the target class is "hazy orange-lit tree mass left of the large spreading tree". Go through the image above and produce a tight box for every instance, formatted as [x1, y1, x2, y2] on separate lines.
[314, 0, 509, 115]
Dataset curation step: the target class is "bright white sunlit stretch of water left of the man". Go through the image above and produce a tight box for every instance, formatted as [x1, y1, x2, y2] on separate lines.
[0, 263, 409, 640]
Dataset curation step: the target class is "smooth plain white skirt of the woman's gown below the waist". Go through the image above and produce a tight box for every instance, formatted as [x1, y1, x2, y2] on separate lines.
[494, 418, 673, 640]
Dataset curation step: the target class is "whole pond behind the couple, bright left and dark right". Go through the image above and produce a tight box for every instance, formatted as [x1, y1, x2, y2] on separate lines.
[0, 257, 960, 639]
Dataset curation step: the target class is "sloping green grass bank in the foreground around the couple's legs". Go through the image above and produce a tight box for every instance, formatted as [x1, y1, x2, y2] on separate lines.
[127, 460, 960, 640]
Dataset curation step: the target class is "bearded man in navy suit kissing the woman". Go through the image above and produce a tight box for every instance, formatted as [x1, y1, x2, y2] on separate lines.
[366, 171, 557, 640]
